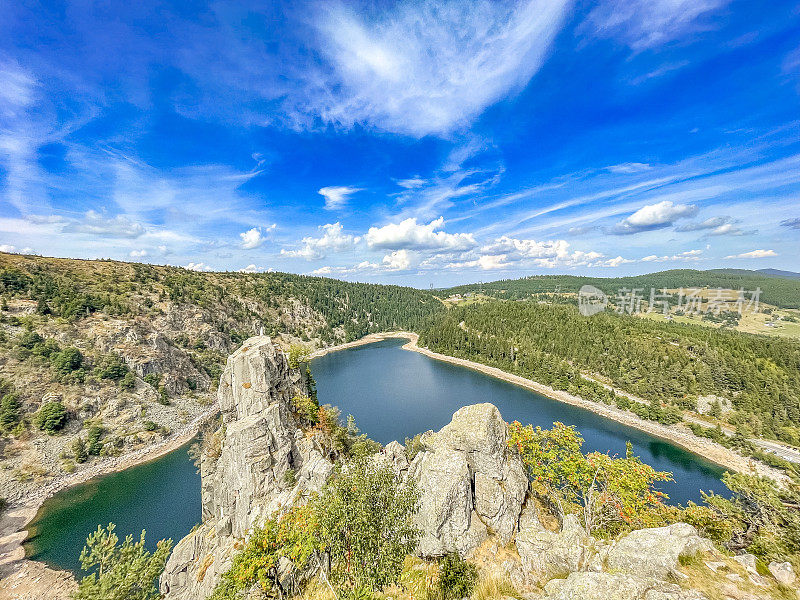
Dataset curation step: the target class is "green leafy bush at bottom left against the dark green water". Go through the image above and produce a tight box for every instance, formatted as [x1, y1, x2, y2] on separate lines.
[73, 523, 172, 600]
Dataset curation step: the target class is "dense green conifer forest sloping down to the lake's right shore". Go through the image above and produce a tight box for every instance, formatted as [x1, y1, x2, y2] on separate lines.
[420, 301, 800, 444]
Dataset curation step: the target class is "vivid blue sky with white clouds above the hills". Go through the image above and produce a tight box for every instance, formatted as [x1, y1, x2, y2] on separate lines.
[0, 0, 800, 287]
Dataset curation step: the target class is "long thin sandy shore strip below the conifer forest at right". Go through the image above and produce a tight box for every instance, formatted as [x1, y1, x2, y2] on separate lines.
[312, 331, 785, 481]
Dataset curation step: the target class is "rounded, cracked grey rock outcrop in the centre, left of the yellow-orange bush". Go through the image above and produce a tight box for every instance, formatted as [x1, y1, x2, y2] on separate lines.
[408, 404, 528, 556]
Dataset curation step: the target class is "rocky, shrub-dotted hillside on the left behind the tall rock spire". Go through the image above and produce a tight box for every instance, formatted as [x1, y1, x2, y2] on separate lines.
[0, 254, 445, 499]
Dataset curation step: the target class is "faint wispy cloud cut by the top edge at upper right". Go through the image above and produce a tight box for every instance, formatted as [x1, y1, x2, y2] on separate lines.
[585, 0, 729, 52]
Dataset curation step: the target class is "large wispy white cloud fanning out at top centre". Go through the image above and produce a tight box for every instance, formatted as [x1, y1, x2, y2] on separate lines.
[302, 0, 571, 137]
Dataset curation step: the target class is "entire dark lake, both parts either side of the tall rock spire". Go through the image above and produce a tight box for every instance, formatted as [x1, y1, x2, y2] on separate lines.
[26, 339, 726, 574]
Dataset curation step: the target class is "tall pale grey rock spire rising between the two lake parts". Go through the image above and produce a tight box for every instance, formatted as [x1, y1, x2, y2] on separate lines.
[160, 336, 333, 600]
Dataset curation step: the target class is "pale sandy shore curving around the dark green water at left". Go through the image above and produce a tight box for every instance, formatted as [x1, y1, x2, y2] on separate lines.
[0, 405, 218, 600]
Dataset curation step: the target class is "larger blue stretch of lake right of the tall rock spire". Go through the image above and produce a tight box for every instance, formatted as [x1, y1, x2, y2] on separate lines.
[312, 339, 727, 504]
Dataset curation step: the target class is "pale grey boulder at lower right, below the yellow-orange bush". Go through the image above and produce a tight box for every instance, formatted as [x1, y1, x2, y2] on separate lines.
[606, 523, 713, 579]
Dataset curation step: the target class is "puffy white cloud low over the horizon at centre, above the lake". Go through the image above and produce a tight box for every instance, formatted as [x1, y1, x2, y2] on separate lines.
[365, 217, 477, 250]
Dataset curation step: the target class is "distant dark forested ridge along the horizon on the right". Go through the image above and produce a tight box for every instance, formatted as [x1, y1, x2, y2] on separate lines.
[445, 269, 800, 308]
